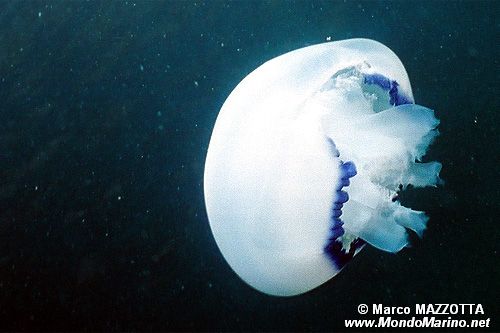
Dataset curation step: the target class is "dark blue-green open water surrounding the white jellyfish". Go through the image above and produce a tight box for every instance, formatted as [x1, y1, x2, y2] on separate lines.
[0, 1, 500, 332]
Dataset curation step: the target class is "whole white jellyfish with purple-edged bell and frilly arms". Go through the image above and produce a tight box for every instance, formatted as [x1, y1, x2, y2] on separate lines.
[204, 39, 441, 296]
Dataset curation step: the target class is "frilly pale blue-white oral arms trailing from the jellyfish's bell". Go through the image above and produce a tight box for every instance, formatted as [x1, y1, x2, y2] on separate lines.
[330, 104, 441, 252]
